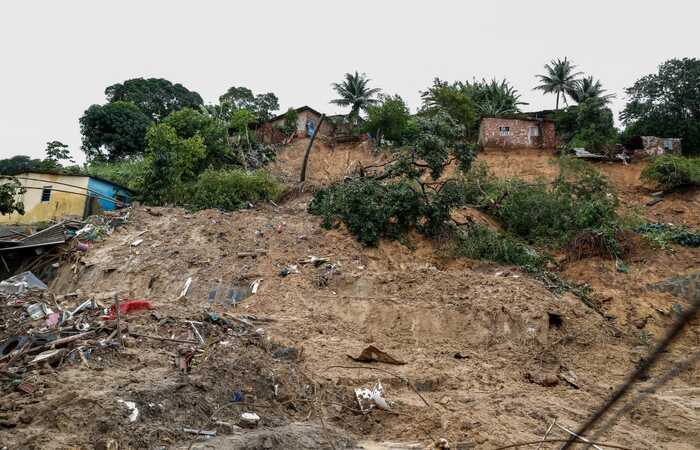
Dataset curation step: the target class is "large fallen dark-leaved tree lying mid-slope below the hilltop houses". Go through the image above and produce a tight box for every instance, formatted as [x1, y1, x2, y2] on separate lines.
[309, 113, 474, 245]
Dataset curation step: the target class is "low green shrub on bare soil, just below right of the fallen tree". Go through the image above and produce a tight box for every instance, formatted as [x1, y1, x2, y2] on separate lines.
[453, 224, 550, 267]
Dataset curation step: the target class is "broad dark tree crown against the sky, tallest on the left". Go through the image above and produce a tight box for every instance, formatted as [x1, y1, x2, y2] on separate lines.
[105, 78, 204, 122]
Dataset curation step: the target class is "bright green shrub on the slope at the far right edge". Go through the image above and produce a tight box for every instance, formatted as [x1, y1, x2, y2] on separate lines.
[641, 155, 700, 189]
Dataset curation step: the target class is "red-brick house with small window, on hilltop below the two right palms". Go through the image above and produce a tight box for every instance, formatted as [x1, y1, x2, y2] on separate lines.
[479, 111, 557, 149]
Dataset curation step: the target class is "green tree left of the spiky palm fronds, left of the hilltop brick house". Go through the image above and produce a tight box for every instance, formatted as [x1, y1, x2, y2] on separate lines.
[421, 78, 479, 137]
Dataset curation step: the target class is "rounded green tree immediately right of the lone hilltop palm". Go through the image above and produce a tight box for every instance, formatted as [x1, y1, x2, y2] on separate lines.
[364, 95, 411, 145]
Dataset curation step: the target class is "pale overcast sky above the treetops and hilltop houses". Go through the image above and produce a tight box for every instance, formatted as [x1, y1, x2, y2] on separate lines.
[0, 0, 700, 161]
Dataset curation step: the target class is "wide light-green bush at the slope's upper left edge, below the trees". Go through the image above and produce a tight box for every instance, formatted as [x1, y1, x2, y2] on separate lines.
[189, 169, 283, 211]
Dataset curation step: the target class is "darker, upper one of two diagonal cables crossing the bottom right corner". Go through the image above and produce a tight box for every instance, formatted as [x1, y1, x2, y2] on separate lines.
[561, 300, 700, 450]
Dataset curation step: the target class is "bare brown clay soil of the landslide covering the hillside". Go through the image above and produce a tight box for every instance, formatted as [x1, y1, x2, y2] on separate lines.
[0, 141, 700, 449]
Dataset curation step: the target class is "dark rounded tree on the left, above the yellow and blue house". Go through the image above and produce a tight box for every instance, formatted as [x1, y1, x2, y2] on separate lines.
[80, 101, 151, 161]
